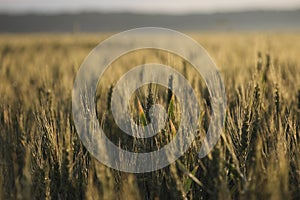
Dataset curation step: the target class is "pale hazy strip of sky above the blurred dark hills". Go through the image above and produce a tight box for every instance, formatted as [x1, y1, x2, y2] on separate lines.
[0, 0, 300, 14]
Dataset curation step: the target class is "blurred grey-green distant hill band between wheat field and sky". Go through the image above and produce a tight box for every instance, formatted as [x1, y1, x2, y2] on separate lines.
[0, 10, 300, 33]
